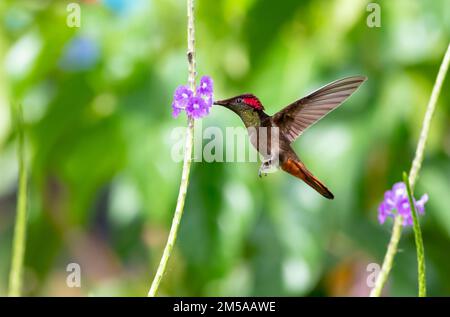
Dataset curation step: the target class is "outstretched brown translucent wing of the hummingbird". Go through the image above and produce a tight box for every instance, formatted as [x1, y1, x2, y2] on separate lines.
[273, 76, 367, 142]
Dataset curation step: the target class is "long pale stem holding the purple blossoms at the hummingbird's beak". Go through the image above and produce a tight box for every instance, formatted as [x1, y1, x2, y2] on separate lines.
[148, 0, 196, 297]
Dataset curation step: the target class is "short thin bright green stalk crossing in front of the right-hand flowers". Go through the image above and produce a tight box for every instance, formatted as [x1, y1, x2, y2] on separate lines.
[403, 172, 427, 297]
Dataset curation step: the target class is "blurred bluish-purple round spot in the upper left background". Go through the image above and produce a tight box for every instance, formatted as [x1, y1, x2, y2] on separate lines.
[60, 37, 100, 71]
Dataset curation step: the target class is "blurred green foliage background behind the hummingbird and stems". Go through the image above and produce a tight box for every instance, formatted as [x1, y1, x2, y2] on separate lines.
[0, 0, 450, 296]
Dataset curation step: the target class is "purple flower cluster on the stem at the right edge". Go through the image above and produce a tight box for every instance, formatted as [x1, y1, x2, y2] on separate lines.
[378, 183, 428, 226]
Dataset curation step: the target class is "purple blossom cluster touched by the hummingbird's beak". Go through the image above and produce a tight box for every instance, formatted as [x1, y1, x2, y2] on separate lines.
[172, 76, 213, 119]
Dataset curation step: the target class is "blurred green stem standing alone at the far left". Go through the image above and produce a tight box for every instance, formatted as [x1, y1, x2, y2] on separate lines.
[8, 104, 27, 296]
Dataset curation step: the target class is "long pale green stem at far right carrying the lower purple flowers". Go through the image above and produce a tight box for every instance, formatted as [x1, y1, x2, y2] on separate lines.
[370, 44, 450, 297]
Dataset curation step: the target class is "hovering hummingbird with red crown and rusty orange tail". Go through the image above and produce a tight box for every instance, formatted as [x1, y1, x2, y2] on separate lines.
[214, 76, 367, 199]
